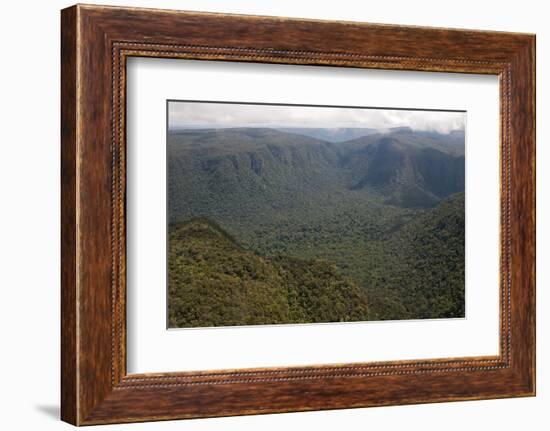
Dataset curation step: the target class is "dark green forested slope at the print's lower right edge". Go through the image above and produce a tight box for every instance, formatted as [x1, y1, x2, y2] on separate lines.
[364, 193, 465, 319]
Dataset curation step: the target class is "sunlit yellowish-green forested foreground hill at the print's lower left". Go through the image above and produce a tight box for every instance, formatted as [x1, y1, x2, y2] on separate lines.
[168, 219, 374, 327]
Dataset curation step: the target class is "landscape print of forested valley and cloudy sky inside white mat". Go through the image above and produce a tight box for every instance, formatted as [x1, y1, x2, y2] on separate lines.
[167, 100, 466, 328]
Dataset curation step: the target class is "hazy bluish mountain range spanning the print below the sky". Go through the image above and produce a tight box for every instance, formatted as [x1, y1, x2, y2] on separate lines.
[168, 128, 465, 220]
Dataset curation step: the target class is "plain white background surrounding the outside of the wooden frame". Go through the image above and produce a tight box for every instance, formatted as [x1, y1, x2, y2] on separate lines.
[0, 0, 550, 431]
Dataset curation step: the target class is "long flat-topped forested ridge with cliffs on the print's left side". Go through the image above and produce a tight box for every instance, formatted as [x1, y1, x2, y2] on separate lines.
[168, 129, 343, 221]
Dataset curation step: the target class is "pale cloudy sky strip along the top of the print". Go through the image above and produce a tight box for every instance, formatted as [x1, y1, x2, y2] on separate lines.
[168, 101, 466, 133]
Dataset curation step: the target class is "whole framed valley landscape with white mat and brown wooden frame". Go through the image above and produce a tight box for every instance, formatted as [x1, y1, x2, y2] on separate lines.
[61, 5, 535, 425]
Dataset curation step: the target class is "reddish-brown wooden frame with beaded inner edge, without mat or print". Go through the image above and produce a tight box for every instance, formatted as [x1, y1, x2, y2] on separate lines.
[61, 5, 535, 425]
